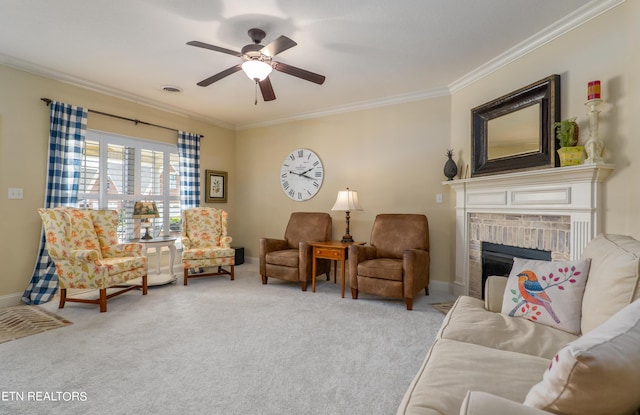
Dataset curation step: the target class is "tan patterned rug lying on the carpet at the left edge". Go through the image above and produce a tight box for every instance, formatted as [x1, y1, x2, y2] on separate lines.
[0, 305, 73, 343]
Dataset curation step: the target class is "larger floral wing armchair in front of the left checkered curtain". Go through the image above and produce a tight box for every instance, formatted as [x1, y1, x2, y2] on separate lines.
[38, 207, 147, 312]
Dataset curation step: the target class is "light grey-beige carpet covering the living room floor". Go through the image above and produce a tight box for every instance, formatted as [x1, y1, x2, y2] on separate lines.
[0, 263, 453, 415]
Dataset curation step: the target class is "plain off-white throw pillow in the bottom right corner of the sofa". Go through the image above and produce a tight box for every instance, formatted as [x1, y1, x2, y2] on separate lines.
[524, 301, 640, 415]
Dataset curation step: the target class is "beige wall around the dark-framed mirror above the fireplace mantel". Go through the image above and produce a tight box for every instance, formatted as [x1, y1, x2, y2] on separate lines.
[451, 1, 640, 244]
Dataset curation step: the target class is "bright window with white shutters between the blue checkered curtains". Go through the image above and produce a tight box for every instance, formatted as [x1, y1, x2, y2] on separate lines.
[78, 130, 180, 242]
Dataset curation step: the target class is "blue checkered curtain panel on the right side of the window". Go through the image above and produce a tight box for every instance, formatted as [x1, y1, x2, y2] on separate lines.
[178, 131, 200, 210]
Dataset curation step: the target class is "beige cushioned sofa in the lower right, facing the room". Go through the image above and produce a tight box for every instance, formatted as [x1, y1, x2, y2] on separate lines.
[397, 235, 640, 415]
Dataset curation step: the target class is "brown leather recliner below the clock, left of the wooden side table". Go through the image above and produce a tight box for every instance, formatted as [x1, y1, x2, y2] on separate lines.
[260, 212, 331, 291]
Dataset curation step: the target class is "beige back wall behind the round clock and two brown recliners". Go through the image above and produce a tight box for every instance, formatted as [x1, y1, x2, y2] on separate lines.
[233, 96, 453, 282]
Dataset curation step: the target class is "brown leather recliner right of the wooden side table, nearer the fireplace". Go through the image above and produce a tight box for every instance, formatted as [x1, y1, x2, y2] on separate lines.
[349, 214, 430, 310]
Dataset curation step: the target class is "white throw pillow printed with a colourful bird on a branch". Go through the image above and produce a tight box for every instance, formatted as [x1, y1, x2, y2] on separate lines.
[502, 258, 590, 334]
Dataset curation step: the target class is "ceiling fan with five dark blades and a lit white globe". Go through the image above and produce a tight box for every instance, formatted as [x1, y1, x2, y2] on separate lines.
[187, 28, 325, 103]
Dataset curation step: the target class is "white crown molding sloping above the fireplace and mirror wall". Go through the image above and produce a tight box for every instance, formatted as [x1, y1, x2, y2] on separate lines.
[449, 0, 626, 93]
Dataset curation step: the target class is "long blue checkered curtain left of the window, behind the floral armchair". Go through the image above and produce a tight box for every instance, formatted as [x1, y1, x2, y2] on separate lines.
[22, 101, 88, 304]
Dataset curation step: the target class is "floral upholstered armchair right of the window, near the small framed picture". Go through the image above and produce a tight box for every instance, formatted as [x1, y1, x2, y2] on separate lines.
[182, 207, 235, 285]
